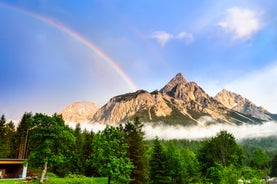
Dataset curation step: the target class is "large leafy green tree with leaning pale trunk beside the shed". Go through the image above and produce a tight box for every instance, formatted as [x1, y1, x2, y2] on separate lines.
[28, 113, 75, 183]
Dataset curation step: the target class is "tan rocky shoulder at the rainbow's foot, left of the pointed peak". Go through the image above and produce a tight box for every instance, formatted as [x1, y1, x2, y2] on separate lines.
[93, 90, 172, 124]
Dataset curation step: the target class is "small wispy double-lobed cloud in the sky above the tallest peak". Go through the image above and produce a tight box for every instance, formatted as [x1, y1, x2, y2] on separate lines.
[151, 31, 194, 47]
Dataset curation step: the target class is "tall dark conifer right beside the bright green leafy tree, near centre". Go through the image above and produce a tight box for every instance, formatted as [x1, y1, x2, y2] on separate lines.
[123, 118, 146, 184]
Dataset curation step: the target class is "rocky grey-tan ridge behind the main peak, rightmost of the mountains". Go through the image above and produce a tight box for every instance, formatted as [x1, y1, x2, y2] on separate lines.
[215, 89, 272, 120]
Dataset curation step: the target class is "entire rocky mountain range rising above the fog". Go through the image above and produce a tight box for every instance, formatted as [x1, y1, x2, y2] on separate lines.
[61, 73, 277, 126]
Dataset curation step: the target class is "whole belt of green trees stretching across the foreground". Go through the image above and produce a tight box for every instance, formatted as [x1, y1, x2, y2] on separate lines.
[0, 113, 277, 184]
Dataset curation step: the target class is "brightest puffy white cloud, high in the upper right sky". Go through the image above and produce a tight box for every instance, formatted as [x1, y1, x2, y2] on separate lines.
[218, 7, 262, 40]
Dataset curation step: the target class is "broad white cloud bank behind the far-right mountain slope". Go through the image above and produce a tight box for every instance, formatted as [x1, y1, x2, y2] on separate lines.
[224, 62, 277, 113]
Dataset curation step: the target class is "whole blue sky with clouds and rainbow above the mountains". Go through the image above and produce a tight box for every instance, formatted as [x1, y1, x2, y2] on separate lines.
[0, 0, 277, 119]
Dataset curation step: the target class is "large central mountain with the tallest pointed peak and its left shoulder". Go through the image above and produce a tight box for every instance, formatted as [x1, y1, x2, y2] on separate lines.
[92, 73, 254, 125]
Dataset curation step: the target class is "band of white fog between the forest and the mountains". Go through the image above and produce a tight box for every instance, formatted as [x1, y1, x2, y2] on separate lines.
[69, 121, 277, 140]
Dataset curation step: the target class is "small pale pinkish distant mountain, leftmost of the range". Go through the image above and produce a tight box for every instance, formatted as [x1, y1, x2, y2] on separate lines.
[59, 102, 100, 123]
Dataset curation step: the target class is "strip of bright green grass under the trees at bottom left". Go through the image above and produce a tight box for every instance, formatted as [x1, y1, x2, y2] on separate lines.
[0, 178, 108, 184]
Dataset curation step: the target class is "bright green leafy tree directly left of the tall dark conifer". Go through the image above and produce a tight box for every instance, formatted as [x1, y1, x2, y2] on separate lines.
[92, 126, 133, 184]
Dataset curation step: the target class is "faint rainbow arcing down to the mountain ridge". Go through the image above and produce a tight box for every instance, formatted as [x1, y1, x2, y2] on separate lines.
[0, 2, 138, 90]
